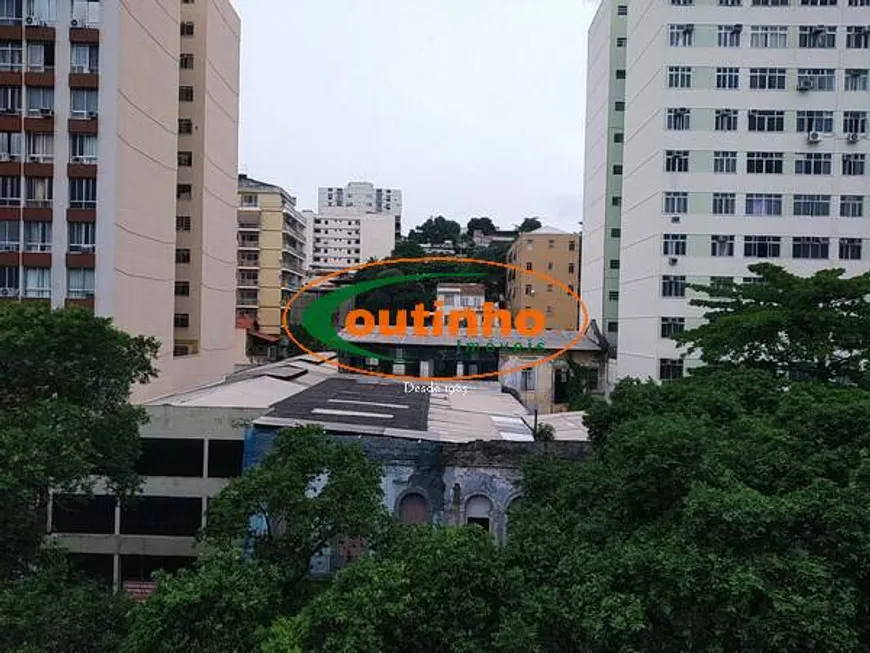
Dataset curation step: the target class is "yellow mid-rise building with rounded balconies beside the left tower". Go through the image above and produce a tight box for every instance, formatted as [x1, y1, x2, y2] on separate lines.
[236, 175, 306, 336]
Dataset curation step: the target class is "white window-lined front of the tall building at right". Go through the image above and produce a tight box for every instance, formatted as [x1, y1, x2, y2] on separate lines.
[584, 0, 870, 380]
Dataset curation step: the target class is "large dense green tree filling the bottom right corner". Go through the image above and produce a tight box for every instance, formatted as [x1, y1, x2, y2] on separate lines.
[497, 368, 870, 653]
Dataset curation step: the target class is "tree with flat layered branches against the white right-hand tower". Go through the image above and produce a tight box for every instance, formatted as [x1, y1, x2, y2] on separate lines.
[678, 263, 870, 387]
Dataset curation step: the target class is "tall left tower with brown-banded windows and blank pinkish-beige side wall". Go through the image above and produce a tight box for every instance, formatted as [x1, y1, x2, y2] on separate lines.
[0, 0, 240, 401]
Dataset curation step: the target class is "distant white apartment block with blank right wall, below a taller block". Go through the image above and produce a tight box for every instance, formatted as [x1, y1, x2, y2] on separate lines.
[302, 207, 396, 276]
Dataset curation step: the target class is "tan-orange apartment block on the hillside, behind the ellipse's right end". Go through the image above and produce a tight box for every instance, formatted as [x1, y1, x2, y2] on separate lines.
[507, 226, 580, 329]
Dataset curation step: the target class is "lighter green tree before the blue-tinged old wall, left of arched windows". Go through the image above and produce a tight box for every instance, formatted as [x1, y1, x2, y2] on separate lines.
[204, 426, 385, 593]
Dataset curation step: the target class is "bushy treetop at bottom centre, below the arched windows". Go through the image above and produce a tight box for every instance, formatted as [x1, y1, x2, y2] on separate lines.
[263, 527, 507, 653]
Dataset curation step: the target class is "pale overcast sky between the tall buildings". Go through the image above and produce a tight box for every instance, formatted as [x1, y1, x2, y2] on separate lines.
[235, 0, 595, 231]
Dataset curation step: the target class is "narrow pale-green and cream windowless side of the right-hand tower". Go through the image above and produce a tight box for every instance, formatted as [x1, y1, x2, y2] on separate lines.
[580, 0, 628, 347]
